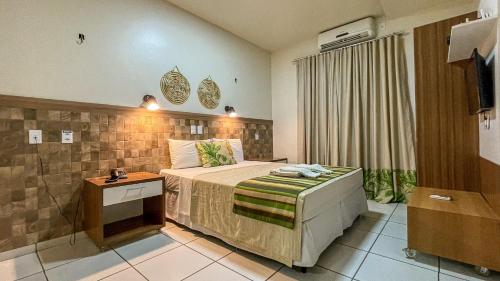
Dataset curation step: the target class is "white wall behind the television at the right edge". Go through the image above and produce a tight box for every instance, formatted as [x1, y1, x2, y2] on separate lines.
[479, 0, 500, 165]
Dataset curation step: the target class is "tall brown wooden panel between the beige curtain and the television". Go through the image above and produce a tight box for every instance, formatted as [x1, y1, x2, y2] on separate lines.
[414, 13, 480, 191]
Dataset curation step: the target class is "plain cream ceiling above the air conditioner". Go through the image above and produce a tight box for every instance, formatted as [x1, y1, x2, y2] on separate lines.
[167, 0, 477, 51]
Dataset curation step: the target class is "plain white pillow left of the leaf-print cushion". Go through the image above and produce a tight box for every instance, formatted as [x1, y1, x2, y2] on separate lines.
[168, 139, 201, 169]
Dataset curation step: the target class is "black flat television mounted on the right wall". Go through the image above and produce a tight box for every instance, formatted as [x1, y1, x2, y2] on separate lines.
[465, 49, 495, 115]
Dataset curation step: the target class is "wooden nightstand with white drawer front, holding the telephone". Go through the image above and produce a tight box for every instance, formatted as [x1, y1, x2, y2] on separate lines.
[83, 173, 165, 249]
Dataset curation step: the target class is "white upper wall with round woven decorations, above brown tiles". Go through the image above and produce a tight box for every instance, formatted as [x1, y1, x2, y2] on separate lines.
[0, 0, 271, 119]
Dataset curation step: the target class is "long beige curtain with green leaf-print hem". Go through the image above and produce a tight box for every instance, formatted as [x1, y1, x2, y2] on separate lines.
[297, 35, 416, 203]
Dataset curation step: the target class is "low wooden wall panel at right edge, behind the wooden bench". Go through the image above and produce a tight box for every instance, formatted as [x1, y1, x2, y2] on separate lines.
[480, 157, 500, 216]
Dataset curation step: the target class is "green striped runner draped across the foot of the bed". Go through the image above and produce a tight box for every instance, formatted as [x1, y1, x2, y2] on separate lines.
[233, 166, 357, 229]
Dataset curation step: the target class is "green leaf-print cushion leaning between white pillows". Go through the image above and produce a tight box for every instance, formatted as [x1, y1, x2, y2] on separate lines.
[196, 141, 236, 168]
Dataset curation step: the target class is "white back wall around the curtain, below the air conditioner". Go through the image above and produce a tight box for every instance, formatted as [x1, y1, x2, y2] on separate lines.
[271, 5, 477, 162]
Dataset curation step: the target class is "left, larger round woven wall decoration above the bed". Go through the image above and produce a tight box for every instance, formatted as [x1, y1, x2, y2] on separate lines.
[160, 66, 191, 104]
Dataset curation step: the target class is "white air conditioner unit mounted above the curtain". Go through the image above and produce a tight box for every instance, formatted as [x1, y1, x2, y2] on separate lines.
[318, 17, 377, 52]
